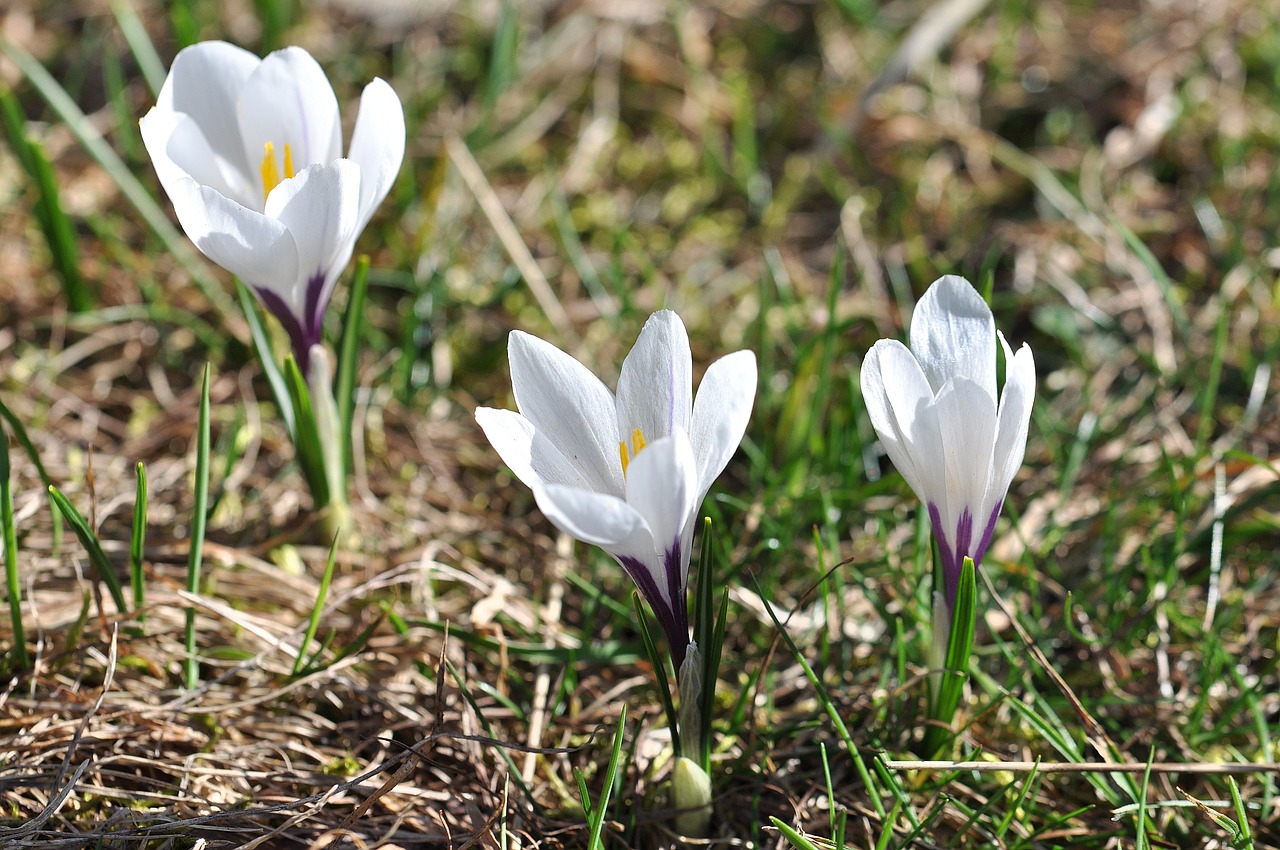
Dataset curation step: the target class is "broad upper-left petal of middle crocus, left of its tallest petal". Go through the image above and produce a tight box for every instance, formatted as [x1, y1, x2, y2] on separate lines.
[507, 330, 623, 498]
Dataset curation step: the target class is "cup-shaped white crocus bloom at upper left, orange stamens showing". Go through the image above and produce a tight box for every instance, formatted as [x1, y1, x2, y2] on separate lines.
[141, 41, 404, 374]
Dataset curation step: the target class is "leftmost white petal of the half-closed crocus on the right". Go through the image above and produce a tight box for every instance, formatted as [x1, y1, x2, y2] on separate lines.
[861, 339, 946, 507]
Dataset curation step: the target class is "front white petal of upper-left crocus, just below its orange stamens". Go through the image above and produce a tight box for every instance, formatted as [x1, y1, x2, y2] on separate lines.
[266, 160, 360, 318]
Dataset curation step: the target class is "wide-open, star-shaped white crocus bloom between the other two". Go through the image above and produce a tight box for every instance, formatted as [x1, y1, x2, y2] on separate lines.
[476, 310, 755, 670]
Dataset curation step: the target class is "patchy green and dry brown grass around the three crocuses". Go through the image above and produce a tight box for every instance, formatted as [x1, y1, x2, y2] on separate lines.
[0, 0, 1280, 850]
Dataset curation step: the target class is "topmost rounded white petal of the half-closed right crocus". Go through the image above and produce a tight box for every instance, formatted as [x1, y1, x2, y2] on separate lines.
[911, 275, 996, 398]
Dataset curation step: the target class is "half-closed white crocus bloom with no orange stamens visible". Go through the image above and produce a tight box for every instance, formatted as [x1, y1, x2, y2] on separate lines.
[861, 275, 1036, 612]
